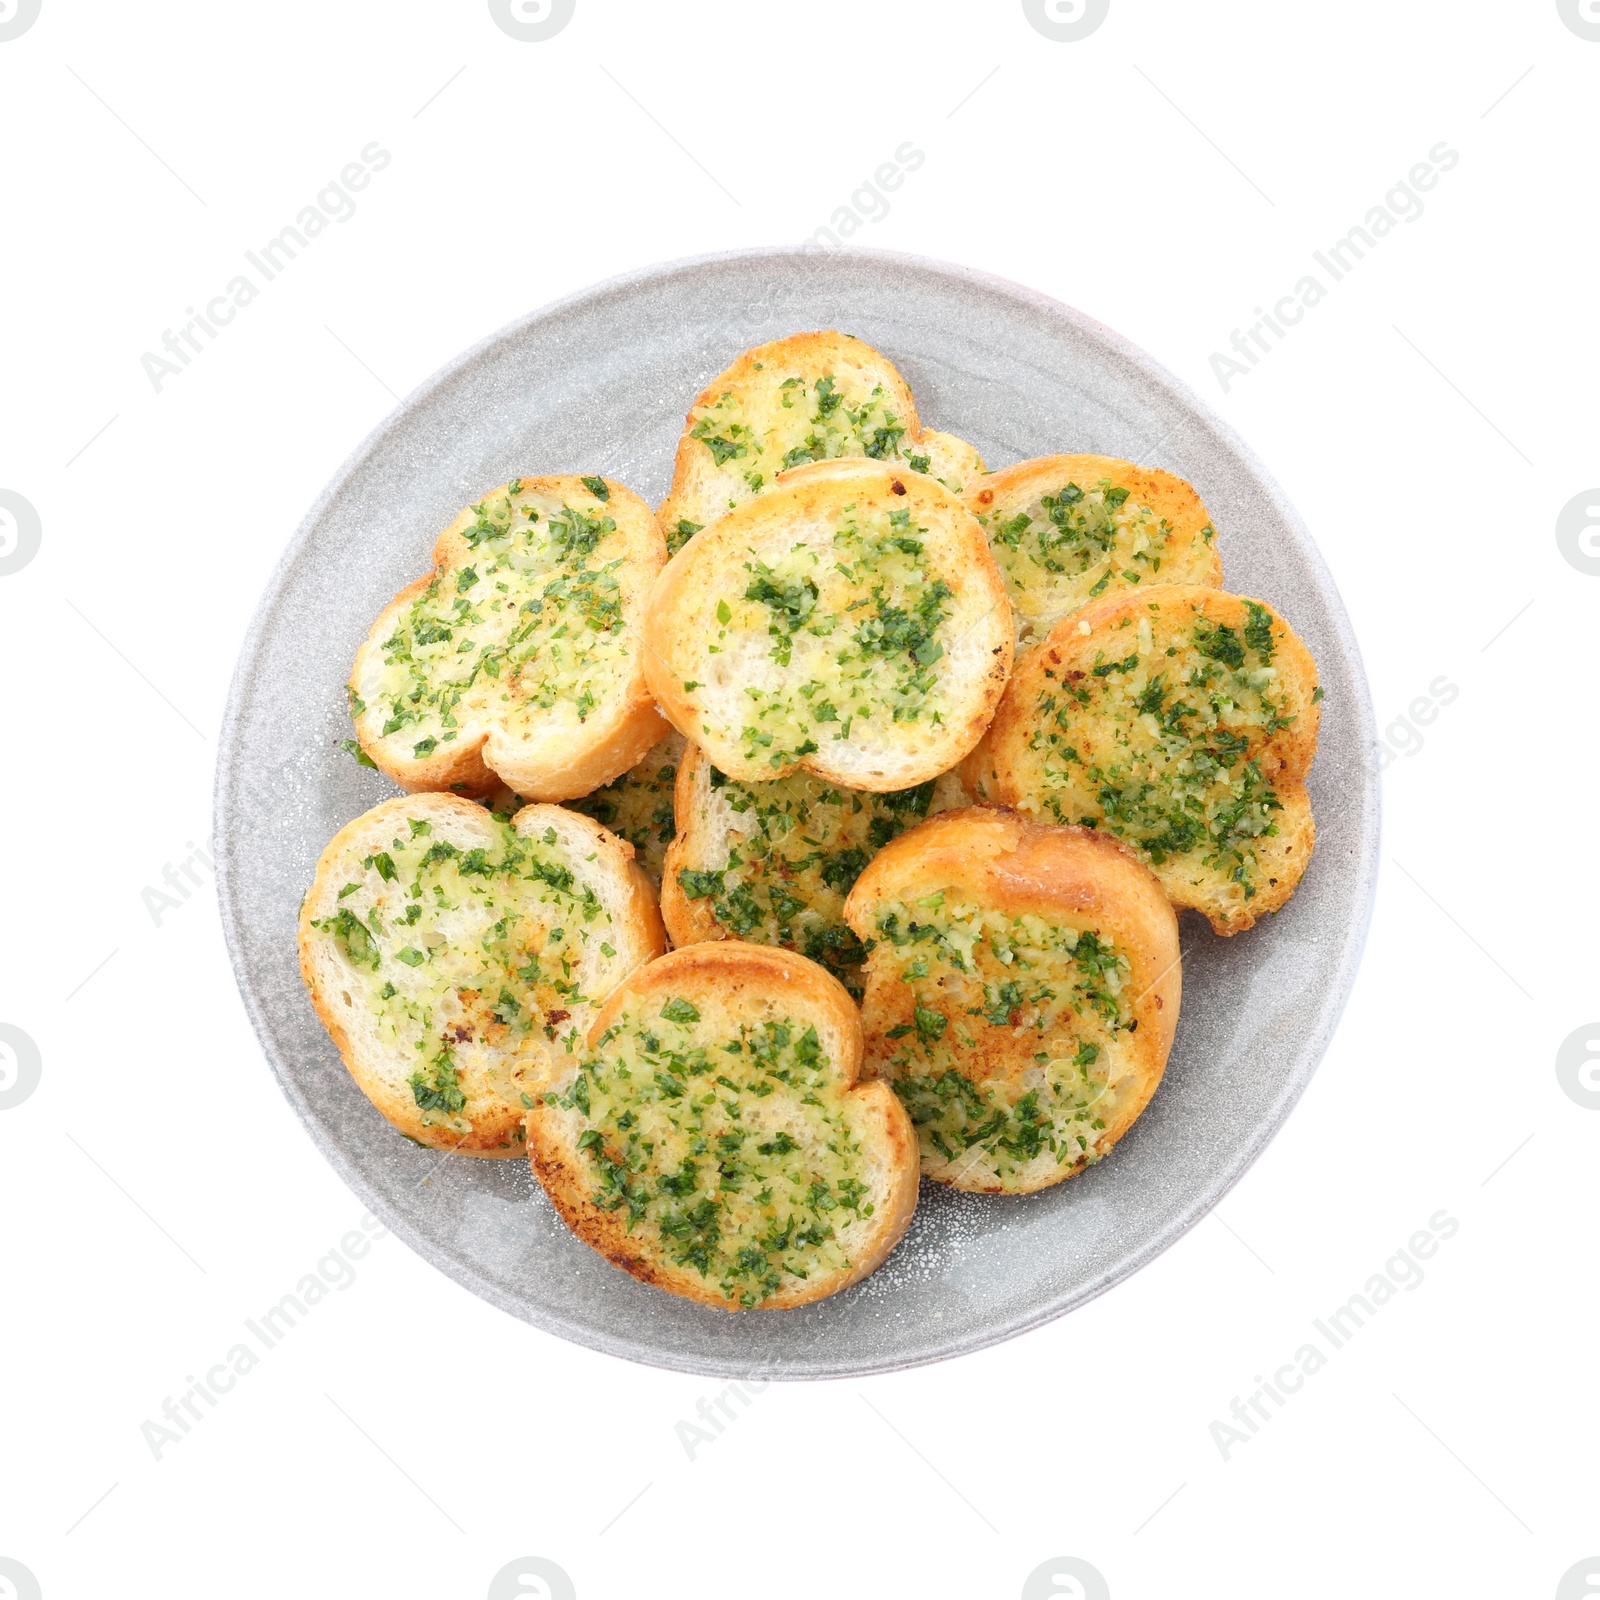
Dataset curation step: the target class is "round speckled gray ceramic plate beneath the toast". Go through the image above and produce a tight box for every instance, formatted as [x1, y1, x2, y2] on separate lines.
[216, 250, 1378, 1378]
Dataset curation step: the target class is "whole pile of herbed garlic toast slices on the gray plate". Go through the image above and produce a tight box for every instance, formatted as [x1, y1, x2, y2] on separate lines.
[299, 333, 1322, 1310]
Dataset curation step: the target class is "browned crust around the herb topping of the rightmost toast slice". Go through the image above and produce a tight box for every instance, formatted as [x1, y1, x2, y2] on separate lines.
[962, 584, 1322, 934]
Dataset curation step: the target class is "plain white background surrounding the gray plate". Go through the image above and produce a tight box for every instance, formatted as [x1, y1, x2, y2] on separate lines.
[0, 0, 1600, 1600]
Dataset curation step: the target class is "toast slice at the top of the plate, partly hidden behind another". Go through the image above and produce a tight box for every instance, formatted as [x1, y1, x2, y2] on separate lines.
[659, 330, 984, 550]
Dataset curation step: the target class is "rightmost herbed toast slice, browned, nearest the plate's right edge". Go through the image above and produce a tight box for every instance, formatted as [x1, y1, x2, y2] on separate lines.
[963, 584, 1322, 934]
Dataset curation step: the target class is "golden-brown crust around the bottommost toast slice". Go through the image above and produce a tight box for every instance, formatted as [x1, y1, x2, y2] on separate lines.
[526, 942, 917, 1310]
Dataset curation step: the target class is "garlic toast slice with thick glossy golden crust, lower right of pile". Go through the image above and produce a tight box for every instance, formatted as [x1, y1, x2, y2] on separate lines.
[845, 806, 1182, 1194]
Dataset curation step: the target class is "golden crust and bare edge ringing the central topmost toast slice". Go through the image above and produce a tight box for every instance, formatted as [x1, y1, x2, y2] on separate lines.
[643, 459, 1014, 792]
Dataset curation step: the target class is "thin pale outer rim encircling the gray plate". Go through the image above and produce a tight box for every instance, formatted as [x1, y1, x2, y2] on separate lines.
[211, 245, 1382, 1381]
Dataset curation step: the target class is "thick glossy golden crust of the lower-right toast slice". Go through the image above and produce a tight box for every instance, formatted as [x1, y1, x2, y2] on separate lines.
[845, 806, 1182, 1194]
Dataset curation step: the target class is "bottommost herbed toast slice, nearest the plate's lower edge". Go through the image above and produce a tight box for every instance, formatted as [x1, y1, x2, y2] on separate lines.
[528, 944, 917, 1310]
